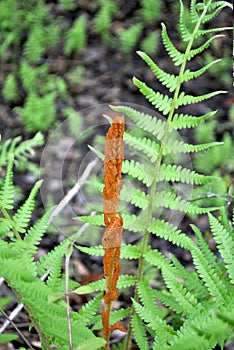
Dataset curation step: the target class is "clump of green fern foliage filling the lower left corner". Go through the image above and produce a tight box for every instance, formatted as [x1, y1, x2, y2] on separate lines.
[0, 144, 105, 350]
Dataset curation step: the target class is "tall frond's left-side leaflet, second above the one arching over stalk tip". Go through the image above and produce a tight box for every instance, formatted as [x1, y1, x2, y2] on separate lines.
[137, 51, 178, 92]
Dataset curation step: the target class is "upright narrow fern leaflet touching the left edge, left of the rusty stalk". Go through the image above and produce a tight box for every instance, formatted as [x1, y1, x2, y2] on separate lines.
[0, 155, 14, 210]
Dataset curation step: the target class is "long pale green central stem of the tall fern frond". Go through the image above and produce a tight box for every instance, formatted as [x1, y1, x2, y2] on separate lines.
[124, 0, 211, 350]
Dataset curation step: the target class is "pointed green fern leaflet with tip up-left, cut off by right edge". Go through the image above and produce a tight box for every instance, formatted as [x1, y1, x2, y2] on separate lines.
[209, 214, 234, 284]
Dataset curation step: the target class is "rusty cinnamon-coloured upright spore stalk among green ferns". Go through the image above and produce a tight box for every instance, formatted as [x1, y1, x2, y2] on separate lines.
[102, 117, 125, 349]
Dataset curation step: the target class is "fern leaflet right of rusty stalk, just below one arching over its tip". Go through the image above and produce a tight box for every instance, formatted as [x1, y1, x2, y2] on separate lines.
[124, 132, 160, 163]
